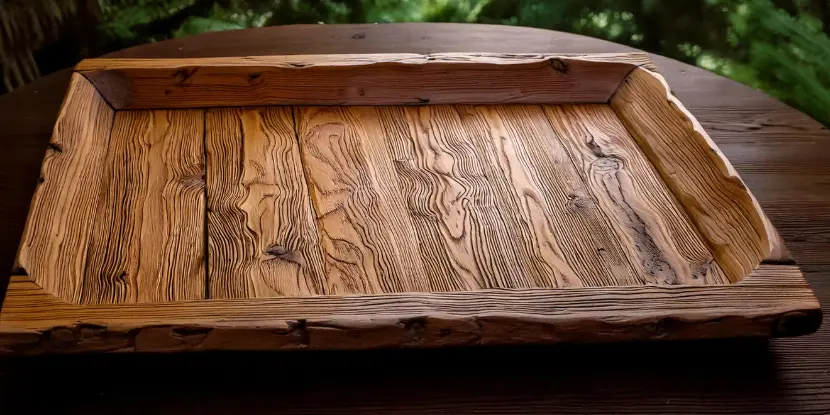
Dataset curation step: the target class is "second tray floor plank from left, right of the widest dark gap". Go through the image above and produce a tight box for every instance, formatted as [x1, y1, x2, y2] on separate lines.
[205, 107, 326, 298]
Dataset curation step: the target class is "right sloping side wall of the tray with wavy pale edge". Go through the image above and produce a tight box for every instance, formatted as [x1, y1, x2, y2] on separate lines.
[611, 68, 775, 282]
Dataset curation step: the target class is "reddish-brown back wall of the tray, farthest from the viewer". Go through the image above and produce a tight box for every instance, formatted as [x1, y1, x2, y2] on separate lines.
[76, 53, 650, 109]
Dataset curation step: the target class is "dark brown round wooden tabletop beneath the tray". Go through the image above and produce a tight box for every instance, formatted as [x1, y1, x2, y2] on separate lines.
[0, 24, 830, 415]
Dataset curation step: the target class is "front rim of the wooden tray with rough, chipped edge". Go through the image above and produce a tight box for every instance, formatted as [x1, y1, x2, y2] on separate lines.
[0, 265, 821, 354]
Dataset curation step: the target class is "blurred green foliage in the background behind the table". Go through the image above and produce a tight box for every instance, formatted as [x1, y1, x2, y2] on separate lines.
[0, 0, 830, 125]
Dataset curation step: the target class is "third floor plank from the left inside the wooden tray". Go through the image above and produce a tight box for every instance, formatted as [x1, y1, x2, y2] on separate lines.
[295, 107, 430, 295]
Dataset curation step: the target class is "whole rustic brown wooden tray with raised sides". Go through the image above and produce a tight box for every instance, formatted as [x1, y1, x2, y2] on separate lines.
[0, 50, 821, 353]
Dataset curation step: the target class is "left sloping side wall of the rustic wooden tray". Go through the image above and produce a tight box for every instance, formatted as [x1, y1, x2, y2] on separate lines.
[18, 74, 113, 302]
